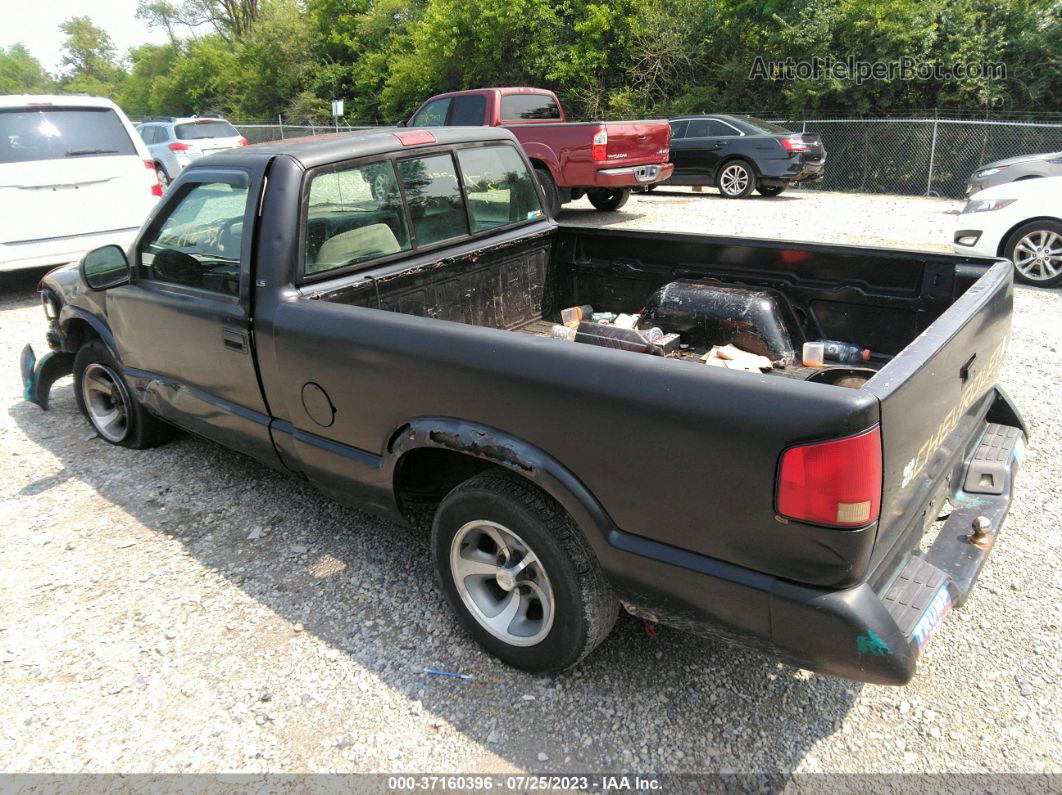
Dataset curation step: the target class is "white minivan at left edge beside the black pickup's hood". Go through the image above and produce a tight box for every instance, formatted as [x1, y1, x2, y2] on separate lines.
[0, 94, 162, 271]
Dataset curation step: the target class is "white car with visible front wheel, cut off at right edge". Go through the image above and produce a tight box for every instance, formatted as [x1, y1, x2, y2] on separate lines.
[952, 176, 1062, 287]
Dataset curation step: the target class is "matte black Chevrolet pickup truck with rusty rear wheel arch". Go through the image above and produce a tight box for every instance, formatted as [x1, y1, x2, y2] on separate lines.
[22, 127, 1025, 685]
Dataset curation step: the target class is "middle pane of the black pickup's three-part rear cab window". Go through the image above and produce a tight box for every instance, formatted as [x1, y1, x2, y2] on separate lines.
[398, 154, 468, 247]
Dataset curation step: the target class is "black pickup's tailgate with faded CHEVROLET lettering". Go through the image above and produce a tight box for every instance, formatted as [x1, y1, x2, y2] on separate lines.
[863, 262, 1013, 564]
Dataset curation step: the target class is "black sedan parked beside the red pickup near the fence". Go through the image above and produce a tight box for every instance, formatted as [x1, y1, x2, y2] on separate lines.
[658, 115, 826, 198]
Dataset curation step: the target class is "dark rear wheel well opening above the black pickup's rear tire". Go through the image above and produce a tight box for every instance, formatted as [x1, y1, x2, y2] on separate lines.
[394, 447, 510, 528]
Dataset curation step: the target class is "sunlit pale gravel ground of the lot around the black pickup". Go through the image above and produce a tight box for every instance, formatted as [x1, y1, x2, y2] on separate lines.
[0, 191, 1062, 773]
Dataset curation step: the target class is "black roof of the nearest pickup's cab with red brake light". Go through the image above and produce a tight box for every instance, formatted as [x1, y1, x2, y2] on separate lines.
[195, 127, 516, 169]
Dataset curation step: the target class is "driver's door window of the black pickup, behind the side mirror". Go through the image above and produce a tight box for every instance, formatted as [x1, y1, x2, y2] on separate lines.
[138, 183, 247, 295]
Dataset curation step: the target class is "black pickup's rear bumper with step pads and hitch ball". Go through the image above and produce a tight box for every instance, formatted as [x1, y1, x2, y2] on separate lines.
[609, 393, 1024, 685]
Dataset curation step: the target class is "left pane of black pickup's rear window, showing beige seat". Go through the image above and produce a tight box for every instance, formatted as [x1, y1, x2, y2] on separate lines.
[303, 160, 410, 276]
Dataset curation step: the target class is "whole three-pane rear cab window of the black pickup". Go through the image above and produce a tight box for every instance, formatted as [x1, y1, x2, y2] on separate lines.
[302, 143, 544, 279]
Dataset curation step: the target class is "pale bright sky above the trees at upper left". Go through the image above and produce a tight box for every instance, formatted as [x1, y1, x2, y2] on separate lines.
[0, 0, 166, 72]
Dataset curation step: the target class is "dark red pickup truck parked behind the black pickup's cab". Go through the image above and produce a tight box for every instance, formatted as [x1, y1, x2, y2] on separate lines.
[408, 88, 674, 215]
